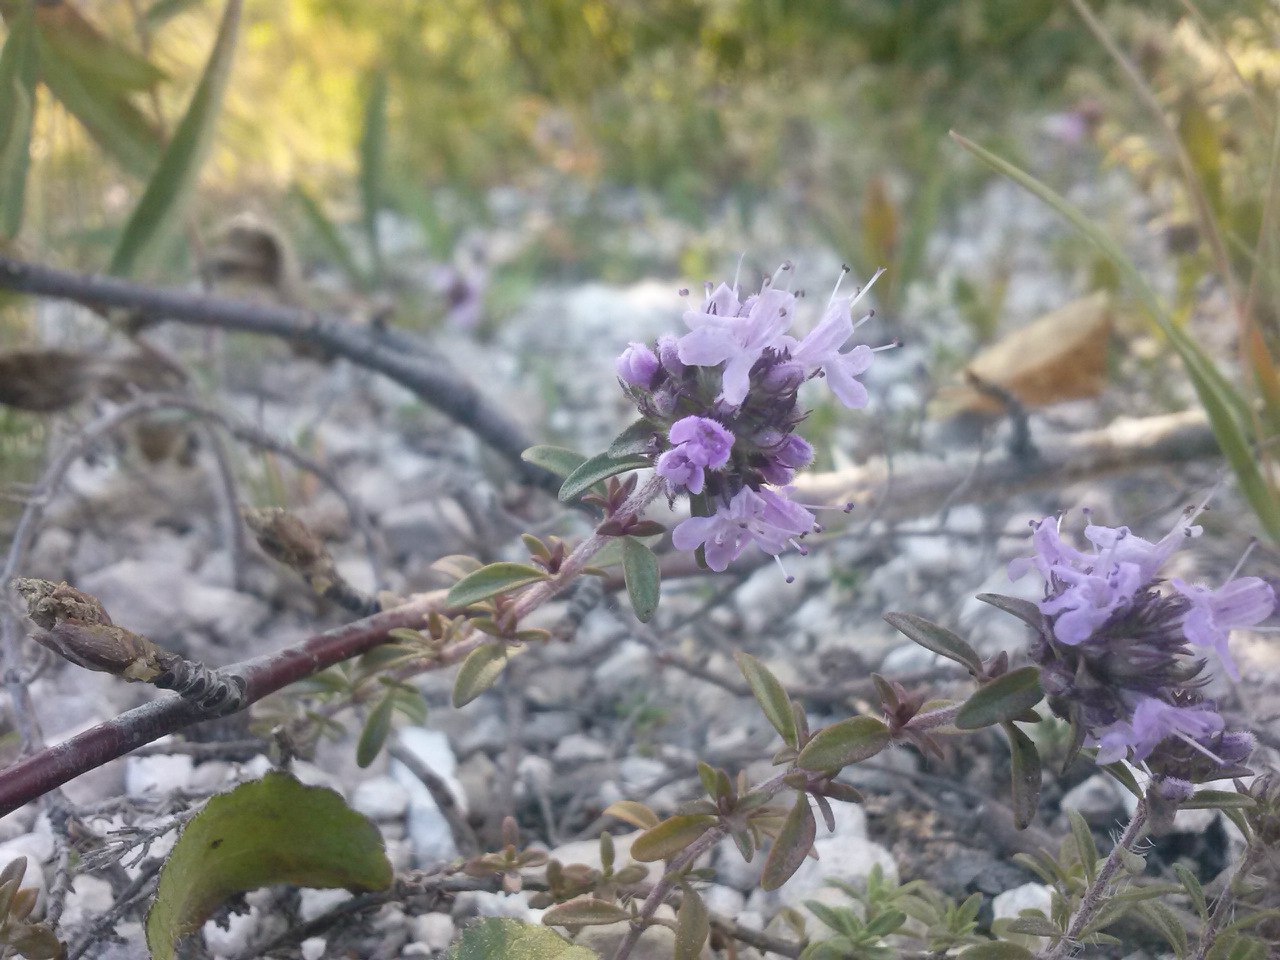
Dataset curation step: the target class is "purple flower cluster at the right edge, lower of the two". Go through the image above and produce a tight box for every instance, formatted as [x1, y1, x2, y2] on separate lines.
[1009, 511, 1276, 782]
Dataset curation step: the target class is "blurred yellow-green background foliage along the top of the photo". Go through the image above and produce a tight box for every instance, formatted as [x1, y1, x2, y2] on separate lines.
[0, 0, 1280, 281]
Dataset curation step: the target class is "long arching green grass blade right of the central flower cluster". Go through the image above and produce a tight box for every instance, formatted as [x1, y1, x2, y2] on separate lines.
[951, 131, 1280, 543]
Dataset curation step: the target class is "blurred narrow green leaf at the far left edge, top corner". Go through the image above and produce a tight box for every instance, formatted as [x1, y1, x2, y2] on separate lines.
[0, 4, 38, 239]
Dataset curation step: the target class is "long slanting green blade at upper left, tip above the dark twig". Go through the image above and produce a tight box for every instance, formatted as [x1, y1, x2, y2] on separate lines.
[109, 0, 241, 276]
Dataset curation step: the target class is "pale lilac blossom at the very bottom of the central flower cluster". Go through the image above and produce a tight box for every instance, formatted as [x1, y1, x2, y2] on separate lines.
[671, 486, 814, 572]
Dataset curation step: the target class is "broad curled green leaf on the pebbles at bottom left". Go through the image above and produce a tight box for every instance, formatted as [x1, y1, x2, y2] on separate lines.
[146, 771, 393, 960]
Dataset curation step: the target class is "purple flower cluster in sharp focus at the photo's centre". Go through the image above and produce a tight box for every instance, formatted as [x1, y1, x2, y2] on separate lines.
[617, 265, 879, 571]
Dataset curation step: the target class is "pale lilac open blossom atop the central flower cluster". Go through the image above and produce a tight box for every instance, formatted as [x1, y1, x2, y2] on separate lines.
[680, 284, 795, 407]
